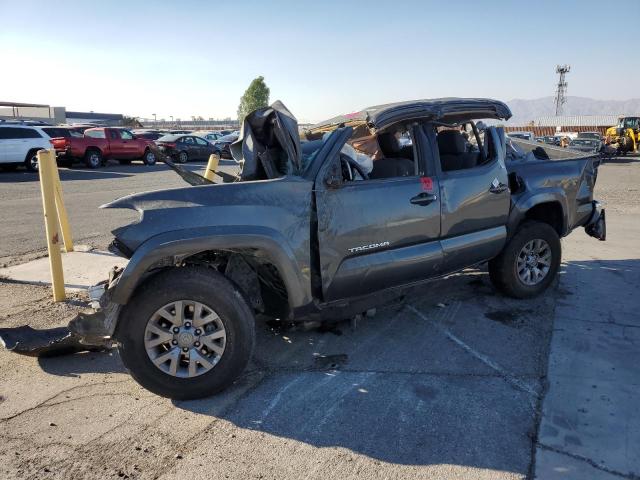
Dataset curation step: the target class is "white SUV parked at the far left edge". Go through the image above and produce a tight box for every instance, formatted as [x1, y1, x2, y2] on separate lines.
[0, 122, 52, 172]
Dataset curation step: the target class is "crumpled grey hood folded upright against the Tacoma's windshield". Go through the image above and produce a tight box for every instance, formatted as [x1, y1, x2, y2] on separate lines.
[230, 100, 302, 180]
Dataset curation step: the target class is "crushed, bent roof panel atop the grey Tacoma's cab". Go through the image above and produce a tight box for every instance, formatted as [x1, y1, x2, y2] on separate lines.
[311, 98, 511, 130]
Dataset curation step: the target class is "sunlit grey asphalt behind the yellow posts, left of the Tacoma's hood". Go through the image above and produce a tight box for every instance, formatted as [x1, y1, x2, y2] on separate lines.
[0, 160, 237, 266]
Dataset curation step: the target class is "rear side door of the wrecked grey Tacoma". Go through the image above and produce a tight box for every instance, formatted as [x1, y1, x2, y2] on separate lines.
[436, 125, 511, 271]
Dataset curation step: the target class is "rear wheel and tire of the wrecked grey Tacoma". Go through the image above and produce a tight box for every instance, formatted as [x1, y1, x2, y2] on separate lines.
[489, 221, 562, 298]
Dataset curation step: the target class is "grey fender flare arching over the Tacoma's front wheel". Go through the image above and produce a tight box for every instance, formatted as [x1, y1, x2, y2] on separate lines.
[110, 225, 312, 309]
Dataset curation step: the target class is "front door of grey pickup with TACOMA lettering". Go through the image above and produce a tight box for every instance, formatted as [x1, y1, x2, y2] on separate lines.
[315, 125, 442, 301]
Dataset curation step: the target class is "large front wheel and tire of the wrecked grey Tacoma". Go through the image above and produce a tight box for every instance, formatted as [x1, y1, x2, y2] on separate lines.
[115, 267, 255, 400]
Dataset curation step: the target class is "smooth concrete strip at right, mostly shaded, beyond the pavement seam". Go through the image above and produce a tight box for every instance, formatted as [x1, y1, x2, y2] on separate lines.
[536, 214, 640, 479]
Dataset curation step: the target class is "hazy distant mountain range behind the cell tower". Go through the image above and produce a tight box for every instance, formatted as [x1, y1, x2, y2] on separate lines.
[507, 97, 640, 124]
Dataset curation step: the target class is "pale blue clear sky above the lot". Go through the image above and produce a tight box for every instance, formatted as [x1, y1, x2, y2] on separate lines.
[0, 0, 640, 121]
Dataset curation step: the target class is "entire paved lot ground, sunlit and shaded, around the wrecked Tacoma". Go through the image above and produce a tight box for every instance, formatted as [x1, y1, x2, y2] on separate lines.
[0, 158, 640, 479]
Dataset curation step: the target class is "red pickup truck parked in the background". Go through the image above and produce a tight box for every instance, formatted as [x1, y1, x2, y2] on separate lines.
[51, 127, 156, 168]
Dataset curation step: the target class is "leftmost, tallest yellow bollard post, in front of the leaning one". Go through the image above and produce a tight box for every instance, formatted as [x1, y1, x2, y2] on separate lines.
[38, 150, 65, 302]
